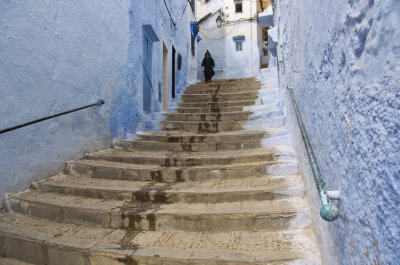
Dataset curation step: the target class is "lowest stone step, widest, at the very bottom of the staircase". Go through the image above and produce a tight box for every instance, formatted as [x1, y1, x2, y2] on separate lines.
[0, 214, 321, 265]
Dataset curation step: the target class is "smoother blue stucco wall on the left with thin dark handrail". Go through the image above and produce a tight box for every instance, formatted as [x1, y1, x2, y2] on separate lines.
[0, 0, 196, 203]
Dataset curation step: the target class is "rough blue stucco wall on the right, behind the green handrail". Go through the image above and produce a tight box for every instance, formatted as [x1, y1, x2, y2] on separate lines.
[275, 0, 400, 265]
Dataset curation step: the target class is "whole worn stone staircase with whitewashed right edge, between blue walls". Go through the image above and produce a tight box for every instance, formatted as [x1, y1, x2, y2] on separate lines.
[0, 75, 321, 265]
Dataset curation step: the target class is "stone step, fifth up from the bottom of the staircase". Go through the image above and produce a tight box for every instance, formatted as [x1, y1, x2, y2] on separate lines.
[84, 146, 295, 167]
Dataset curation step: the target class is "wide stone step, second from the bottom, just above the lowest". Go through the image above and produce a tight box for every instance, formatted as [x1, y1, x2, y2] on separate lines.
[7, 191, 310, 232]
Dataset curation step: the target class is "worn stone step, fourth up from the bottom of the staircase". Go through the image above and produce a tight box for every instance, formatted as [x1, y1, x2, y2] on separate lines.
[66, 157, 298, 182]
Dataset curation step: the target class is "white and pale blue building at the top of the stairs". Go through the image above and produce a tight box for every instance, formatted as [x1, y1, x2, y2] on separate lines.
[196, 0, 264, 80]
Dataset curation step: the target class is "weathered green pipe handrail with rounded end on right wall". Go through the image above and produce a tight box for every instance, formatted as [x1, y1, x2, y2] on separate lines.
[287, 86, 339, 222]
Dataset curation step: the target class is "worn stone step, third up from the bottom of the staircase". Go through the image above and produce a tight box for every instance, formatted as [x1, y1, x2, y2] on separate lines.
[33, 174, 304, 203]
